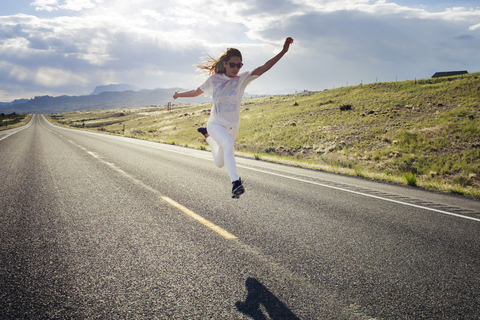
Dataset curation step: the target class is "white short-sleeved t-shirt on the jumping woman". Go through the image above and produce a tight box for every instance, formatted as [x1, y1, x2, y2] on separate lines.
[199, 71, 259, 126]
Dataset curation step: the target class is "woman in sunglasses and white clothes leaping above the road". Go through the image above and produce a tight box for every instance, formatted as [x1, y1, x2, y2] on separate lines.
[173, 38, 293, 198]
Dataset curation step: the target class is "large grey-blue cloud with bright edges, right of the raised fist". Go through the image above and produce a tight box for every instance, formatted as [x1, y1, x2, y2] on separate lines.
[226, 1, 480, 74]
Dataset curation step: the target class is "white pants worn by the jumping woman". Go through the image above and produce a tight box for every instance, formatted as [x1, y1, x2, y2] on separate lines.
[207, 122, 239, 182]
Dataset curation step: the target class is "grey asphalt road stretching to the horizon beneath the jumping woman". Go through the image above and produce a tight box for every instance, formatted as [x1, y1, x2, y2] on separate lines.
[0, 115, 480, 319]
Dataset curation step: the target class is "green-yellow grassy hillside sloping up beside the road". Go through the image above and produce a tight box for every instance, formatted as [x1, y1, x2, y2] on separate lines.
[47, 73, 480, 197]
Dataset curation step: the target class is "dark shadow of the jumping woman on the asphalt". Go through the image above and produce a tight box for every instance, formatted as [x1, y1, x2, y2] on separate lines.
[235, 278, 299, 320]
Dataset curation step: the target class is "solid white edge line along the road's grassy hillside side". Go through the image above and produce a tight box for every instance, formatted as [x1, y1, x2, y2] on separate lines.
[43, 115, 480, 222]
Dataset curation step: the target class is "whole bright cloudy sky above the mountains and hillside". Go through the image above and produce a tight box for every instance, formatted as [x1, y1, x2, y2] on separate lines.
[0, 0, 480, 102]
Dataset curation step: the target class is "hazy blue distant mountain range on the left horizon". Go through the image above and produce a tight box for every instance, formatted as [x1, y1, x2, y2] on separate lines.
[0, 88, 211, 114]
